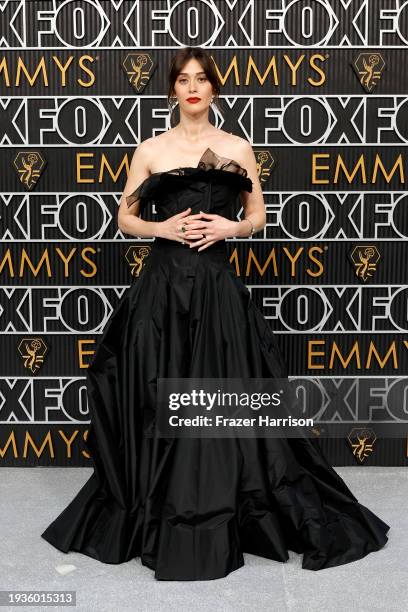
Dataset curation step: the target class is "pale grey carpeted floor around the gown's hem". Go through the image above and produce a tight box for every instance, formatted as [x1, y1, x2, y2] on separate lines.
[0, 466, 408, 612]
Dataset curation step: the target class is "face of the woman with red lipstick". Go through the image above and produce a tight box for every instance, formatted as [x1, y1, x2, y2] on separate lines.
[174, 59, 213, 113]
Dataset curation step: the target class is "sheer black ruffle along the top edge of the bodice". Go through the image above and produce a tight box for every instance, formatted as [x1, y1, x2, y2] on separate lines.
[126, 148, 252, 208]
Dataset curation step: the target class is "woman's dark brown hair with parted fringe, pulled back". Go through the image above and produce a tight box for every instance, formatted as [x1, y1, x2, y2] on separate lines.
[167, 47, 222, 125]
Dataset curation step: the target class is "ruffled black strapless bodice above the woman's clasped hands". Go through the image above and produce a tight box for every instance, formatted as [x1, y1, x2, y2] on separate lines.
[126, 148, 252, 221]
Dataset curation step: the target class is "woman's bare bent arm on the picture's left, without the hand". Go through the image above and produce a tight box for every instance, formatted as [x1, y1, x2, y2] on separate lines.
[118, 141, 158, 238]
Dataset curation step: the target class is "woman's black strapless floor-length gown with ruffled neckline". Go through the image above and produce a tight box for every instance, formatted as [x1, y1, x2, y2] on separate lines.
[42, 149, 389, 580]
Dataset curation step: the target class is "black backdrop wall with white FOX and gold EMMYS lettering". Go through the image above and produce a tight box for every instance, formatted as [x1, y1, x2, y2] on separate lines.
[0, 0, 408, 466]
